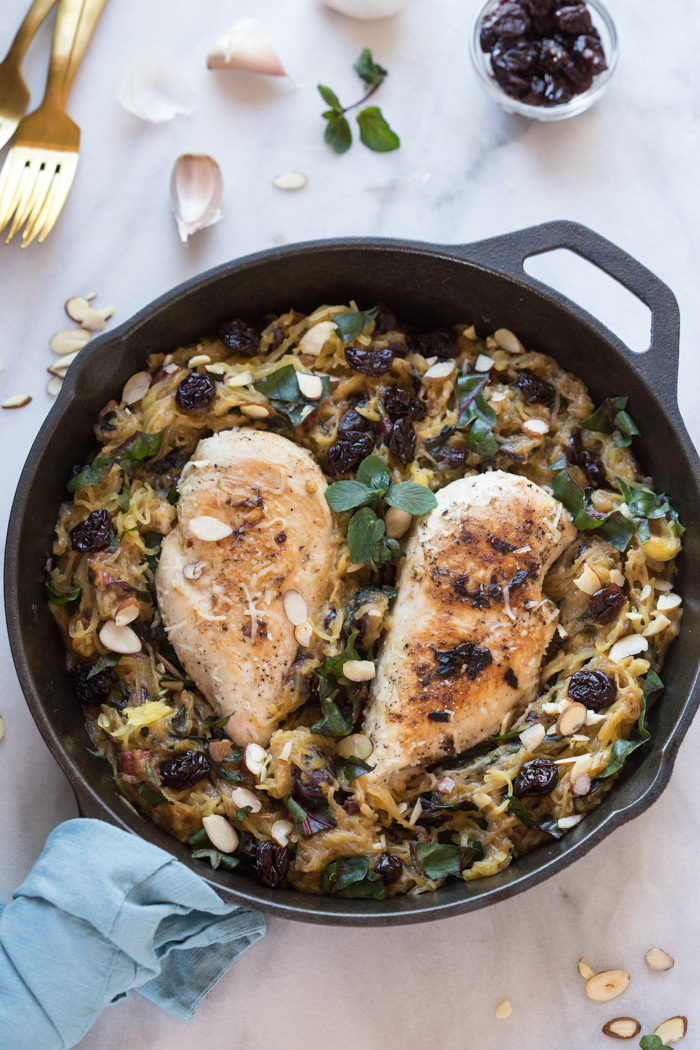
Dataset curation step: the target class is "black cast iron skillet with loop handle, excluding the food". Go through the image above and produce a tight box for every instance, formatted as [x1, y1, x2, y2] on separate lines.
[5, 223, 700, 925]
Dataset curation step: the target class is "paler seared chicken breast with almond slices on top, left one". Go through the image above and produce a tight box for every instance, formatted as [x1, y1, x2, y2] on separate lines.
[155, 428, 332, 746]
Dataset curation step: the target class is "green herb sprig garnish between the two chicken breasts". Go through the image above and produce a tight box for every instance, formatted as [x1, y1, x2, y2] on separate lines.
[325, 456, 438, 569]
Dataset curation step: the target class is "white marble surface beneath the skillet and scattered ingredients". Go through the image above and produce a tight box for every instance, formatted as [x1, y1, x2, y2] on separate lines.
[0, 0, 700, 1050]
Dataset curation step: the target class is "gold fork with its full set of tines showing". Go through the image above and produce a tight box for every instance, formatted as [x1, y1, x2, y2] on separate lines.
[0, 0, 106, 248]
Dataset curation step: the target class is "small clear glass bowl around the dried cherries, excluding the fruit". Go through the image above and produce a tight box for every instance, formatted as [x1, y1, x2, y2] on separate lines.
[469, 0, 617, 121]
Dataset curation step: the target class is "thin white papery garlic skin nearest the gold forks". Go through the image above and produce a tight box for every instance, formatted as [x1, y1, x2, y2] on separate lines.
[116, 44, 195, 124]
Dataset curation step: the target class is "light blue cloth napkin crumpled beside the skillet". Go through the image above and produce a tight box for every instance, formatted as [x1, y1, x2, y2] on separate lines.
[0, 819, 264, 1050]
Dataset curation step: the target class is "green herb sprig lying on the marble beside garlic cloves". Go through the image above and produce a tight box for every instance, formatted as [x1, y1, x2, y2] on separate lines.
[318, 47, 401, 153]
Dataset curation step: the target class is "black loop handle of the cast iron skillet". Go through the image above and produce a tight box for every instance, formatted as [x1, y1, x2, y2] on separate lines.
[452, 221, 680, 396]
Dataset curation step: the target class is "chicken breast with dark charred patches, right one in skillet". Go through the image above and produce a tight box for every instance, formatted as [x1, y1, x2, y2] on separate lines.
[365, 470, 576, 777]
